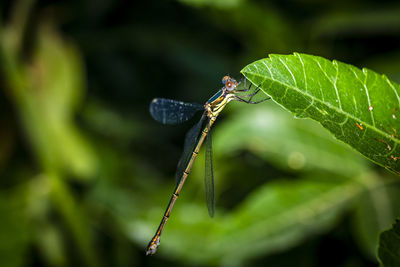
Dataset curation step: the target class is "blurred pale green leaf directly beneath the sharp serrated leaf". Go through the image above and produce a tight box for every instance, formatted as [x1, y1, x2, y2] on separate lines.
[214, 103, 368, 176]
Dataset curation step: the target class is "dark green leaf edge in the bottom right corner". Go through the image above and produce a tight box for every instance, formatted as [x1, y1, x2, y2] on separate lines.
[378, 218, 400, 267]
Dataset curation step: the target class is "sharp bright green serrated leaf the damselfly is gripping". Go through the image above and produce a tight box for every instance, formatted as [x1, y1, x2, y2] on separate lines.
[242, 53, 400, 174]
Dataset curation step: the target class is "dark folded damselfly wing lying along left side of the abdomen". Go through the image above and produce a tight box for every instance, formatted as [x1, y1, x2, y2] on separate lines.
[176, 114, 207, 183]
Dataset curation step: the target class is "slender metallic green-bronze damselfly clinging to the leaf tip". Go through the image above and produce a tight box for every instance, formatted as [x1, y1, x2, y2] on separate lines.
[146, 76, 269, 255]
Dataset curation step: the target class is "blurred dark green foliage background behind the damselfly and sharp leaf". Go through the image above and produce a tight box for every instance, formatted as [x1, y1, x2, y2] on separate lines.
[0, 0, 400, 267]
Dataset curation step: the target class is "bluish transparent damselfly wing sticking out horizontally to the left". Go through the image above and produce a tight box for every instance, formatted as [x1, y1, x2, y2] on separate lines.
[150, 98, 204, 124]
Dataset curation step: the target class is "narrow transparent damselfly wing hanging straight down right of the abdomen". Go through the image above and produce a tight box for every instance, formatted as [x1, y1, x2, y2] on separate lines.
[204, 129, 215, 217]
